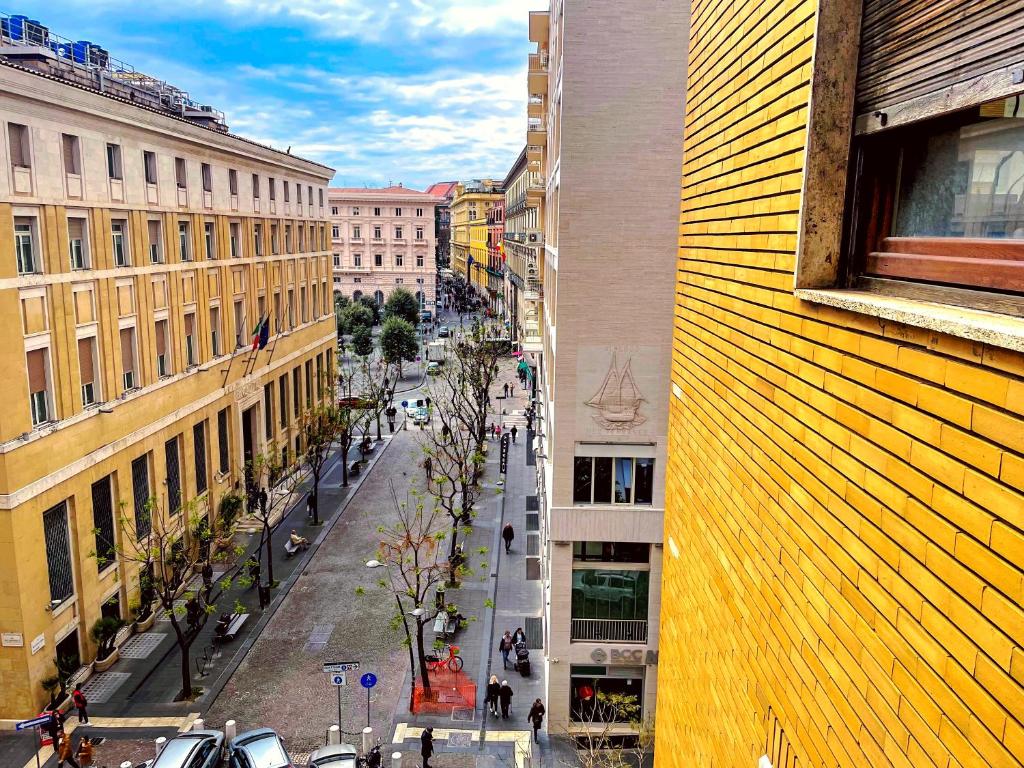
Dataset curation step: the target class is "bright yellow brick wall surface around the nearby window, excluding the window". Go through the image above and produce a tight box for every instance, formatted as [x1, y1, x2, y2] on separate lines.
[656, 0, 1024, 768]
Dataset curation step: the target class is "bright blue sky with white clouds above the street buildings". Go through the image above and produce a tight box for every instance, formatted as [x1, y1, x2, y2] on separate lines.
[16, 0, 532, 188]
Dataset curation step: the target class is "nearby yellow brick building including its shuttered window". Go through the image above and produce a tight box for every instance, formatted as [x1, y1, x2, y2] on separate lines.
[656, 0, 1024, 768]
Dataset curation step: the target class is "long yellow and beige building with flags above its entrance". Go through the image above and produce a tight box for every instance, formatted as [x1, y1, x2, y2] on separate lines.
[0, 40, 335, 719]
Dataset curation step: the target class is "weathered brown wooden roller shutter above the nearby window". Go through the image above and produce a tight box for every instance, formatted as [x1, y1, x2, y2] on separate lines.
[856, 0, 1024, 115]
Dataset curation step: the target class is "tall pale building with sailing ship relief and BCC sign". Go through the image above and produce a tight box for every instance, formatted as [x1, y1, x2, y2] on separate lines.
[525, 0, 688, 732]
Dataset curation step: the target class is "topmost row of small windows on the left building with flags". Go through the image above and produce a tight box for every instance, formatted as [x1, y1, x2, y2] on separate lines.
[7, 123, 325, 216]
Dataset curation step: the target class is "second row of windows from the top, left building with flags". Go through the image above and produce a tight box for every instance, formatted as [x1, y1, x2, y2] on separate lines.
[14, 214, 327, 274]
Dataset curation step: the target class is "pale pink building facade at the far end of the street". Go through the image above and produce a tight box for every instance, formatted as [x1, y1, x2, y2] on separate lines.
[328, 186, 442, 311]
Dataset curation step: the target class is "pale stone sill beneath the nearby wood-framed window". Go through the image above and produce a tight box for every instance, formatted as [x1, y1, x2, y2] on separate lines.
[795, 288, 1024, 352]
